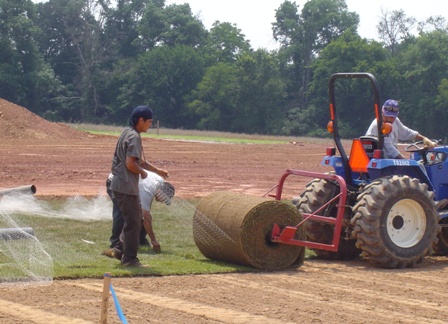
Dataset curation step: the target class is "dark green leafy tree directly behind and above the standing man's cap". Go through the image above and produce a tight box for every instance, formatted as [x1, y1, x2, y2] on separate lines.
[113, 46, 204, 128]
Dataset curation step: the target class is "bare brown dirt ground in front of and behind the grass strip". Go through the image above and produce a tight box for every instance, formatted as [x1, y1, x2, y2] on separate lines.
[0, 100, 448, 323]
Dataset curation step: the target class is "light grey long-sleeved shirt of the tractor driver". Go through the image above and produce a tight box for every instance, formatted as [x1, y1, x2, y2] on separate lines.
[366, 118, 418, 159]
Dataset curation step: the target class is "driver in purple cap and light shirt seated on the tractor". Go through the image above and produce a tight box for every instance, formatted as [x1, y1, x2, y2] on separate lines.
[366, 99, 437, 159]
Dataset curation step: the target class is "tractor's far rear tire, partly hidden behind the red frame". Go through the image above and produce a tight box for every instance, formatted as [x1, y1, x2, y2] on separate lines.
[293, 179, 361, 260]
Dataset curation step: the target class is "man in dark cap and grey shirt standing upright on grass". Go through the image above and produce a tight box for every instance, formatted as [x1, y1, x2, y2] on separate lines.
[110, 106, 168, 267]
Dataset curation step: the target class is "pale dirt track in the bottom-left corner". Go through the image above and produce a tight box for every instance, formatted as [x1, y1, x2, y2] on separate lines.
[0, 300, 93, 324]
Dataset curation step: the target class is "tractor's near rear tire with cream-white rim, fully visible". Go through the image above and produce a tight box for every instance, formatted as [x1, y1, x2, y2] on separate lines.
[352, 176, 440, 268]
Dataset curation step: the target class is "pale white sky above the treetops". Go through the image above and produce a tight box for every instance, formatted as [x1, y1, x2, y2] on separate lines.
[165, 0, 448, 50]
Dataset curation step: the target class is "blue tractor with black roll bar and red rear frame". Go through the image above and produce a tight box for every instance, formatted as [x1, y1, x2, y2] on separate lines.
[271, 73, 448, 268]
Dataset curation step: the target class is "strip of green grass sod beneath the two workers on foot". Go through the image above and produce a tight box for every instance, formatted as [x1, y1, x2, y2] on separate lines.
[0, 197, 255, 279]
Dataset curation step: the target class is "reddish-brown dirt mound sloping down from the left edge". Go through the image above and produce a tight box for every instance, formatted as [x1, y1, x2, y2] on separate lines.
[0, 98, 89, 139]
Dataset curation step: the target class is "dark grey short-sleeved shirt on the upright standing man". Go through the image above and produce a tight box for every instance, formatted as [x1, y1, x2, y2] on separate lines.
[110, 127, 143, 196]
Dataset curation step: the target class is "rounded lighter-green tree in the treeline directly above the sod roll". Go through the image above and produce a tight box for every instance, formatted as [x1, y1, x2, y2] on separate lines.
[188, 49, 286, 134]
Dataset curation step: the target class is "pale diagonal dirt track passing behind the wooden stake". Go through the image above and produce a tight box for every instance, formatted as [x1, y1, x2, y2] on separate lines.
[64, 282, 294, 324]
